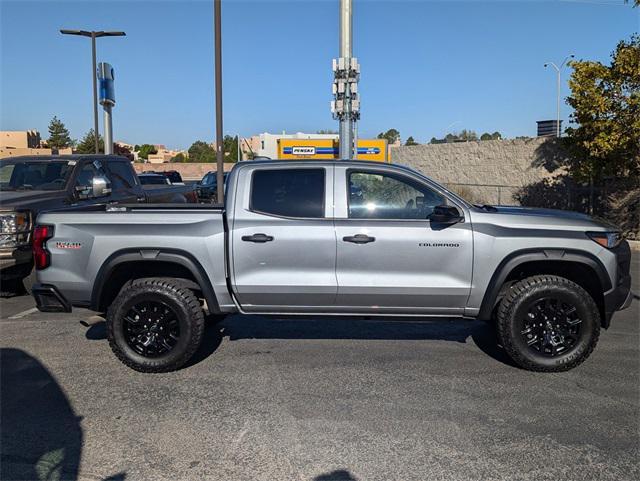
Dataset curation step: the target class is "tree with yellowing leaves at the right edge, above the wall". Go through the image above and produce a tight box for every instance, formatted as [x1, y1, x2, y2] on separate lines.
[566, 35, 640, 182]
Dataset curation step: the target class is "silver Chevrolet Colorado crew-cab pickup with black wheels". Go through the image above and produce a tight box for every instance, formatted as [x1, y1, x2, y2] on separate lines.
[34, 161, 631, 372]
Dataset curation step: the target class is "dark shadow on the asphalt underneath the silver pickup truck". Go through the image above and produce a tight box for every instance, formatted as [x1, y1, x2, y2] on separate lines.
[85, 315, 515, 367]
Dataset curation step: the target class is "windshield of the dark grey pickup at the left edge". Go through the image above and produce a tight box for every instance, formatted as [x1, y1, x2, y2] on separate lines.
[0, 160, 75, 191]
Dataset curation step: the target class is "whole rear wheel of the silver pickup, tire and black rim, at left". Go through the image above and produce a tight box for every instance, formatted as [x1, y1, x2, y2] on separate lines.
[107, 278, 204, 372]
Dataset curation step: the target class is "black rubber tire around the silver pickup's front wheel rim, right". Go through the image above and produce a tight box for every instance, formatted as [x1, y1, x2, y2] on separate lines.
[496, 275, 600, 372]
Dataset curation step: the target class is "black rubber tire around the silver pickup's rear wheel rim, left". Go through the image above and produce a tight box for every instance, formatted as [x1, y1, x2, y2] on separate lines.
[107, 278, 205, 373]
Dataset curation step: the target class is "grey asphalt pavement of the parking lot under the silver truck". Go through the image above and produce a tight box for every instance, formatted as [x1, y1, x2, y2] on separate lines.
[0, 253, 640, 481]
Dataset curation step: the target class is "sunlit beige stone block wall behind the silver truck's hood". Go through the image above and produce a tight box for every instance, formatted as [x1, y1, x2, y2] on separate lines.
[391, 138, 553, 204]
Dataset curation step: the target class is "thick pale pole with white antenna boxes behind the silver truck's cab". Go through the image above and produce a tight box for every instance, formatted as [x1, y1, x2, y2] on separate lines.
[331, 0, 360, 160]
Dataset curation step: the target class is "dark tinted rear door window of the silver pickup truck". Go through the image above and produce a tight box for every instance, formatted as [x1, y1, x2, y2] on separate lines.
[250, 169, 324, 218]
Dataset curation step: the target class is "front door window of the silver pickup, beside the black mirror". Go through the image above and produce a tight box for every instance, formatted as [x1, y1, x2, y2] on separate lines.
[348, 172, 446, 220]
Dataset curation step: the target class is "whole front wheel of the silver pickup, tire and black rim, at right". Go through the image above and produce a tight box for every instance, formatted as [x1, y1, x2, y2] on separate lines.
[497, 275, 600, 372]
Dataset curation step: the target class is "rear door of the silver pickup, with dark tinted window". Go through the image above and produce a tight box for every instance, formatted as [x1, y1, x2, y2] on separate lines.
[229, 163, 337, 312]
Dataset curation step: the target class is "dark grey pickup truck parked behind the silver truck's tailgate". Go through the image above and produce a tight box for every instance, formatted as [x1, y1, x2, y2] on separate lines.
[0, 155, 197, 284]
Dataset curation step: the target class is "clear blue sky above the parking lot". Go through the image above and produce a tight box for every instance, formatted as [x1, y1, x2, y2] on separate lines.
[0, 0, 640, 148]
